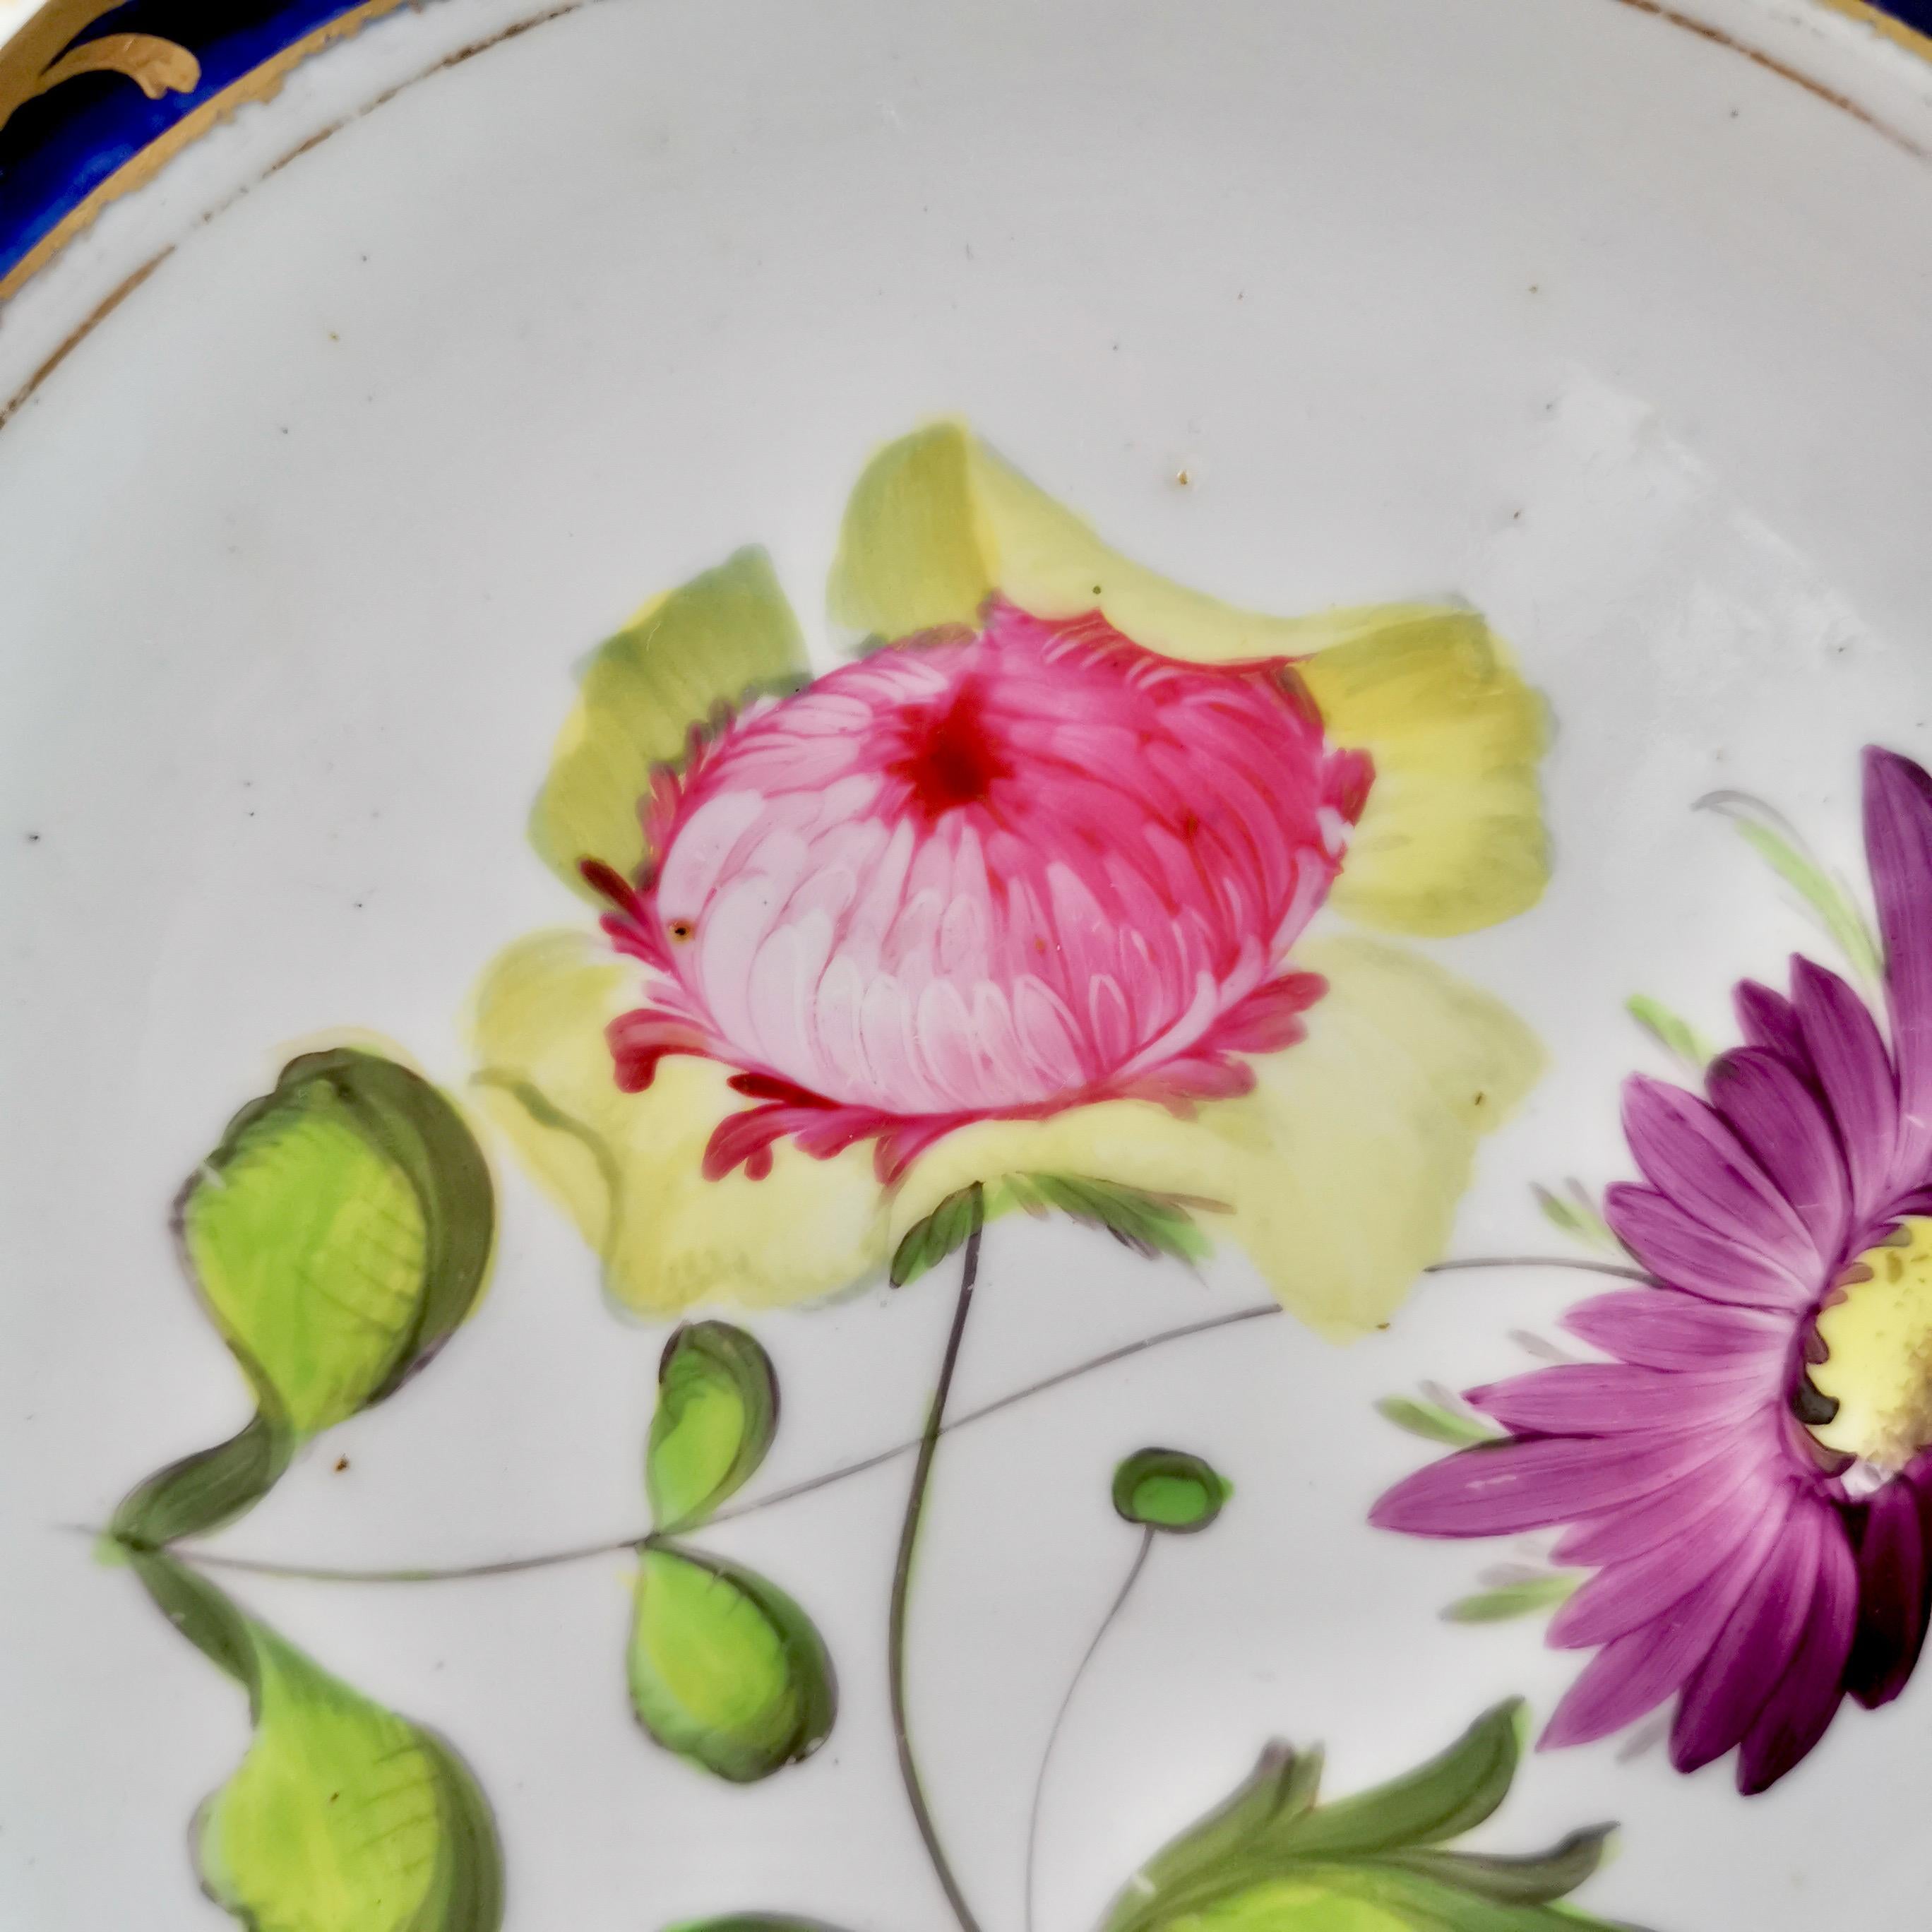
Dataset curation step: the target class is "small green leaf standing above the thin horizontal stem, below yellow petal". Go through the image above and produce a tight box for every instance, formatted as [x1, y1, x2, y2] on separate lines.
[643, 1321, 779, 1534]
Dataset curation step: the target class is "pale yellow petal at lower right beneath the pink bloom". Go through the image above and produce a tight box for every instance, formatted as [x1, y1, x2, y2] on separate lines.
[893, 939, 1542, 1339]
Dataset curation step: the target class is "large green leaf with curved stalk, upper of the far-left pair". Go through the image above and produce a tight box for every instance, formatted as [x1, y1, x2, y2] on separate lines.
[114, 1049, 494, 1548]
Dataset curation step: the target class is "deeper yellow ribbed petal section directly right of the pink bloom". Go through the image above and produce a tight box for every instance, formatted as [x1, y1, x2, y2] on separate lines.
[1300, 611, 1549, 937]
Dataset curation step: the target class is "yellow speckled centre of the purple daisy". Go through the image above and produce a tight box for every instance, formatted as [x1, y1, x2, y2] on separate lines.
[1811, 1215, 1932, 1474]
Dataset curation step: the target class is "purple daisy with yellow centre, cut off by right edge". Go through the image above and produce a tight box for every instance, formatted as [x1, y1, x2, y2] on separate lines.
[1372, 748, 1932, 1793]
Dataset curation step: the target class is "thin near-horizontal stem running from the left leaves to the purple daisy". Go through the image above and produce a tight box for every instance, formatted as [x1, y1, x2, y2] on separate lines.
[132, 1254, 1656, 1582]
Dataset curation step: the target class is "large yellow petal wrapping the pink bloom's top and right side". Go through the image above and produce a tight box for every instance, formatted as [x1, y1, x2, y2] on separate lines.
[829, 423, 1549, 937]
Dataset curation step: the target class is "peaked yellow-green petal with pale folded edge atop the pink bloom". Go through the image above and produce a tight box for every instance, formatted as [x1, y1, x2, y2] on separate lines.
[827, 423, 1439, 662]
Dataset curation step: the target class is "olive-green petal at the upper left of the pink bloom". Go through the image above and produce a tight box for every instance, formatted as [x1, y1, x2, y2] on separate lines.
[530, 549, 808, 898]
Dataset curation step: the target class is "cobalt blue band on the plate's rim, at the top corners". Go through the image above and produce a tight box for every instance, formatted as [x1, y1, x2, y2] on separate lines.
[0, 0, 1932, 299]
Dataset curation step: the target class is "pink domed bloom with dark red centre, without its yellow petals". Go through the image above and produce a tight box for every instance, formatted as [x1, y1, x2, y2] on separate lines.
[599, 599, 1370, 1182]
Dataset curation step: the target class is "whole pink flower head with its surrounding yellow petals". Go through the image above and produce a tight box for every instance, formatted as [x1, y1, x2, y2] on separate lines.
[477, 427, 1546, 1333]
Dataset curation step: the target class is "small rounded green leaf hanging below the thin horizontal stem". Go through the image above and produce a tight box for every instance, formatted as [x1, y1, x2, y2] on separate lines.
[630, 1542, 838, 1785]
